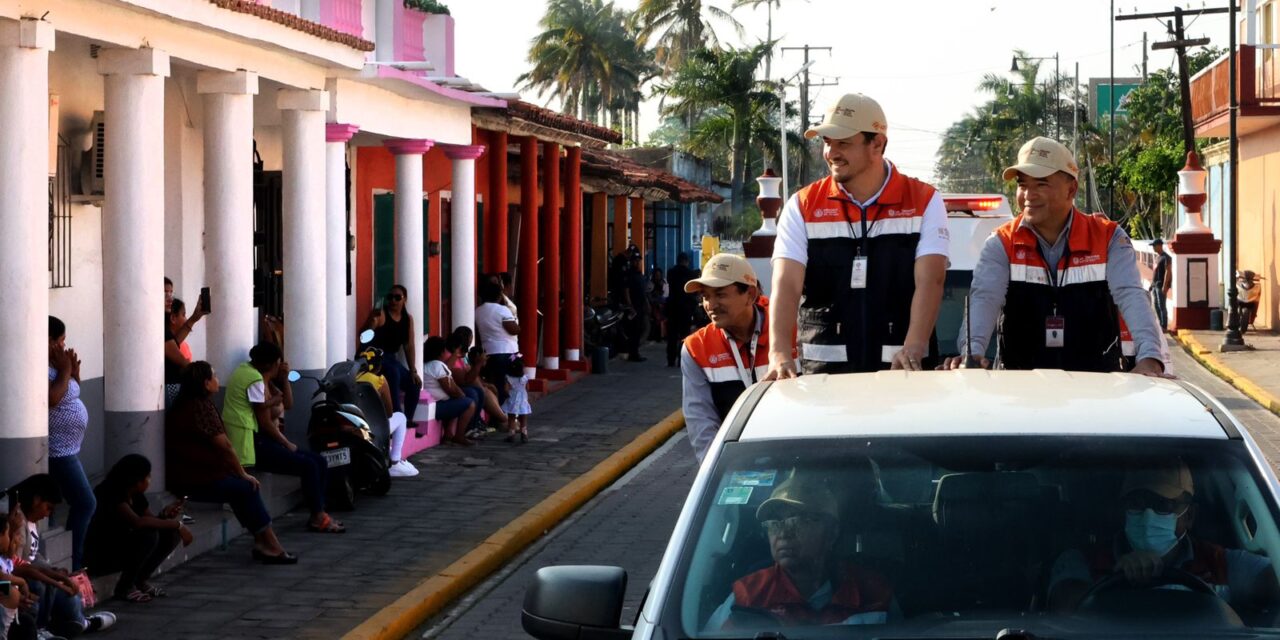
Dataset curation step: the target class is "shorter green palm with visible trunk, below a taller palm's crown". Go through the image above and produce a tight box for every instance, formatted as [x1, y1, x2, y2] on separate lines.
[660, 45, 774, 214]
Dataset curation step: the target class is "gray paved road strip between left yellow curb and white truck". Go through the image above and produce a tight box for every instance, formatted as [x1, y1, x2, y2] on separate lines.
[424, 433, 698, 640]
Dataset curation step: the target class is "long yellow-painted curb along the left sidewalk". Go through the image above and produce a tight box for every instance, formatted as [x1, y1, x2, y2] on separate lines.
[342, 410, 685, 640]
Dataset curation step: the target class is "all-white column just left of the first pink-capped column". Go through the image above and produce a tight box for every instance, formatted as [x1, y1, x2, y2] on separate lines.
[276, 90, 329, 374]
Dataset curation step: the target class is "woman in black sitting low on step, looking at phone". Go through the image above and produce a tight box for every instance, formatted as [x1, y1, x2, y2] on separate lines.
[84, 453, 195, 603]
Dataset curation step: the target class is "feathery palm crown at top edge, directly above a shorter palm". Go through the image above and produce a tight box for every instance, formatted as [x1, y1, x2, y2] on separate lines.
[632, 0, 744, 72]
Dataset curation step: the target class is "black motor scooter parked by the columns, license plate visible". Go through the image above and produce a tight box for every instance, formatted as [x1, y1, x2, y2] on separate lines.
[289, 332, 392, 511]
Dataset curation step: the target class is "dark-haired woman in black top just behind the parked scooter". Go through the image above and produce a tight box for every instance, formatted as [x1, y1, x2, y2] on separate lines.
[356, 284, 422, 421]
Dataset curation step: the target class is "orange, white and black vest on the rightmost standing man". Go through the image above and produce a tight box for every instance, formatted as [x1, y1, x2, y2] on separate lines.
[996, 209, 1121, 371]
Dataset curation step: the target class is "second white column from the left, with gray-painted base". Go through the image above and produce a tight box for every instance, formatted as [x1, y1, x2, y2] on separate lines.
[97, 49, 169, 490]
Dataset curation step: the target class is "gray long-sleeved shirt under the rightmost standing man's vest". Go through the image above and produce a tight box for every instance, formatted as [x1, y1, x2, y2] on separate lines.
[956, 215, 1166, 366]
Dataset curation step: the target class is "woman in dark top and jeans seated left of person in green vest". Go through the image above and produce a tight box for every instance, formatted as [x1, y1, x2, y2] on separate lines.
[165, 361, 298, 564]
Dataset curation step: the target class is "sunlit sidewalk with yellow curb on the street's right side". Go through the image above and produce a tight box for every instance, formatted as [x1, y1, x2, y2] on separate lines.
[1178, 329, 1280, 415]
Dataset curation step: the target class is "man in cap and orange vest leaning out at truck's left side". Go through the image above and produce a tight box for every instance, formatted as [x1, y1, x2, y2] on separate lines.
[680, 253, 769, 461]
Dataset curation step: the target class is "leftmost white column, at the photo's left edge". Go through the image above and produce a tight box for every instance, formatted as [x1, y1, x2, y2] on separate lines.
[0, 19, 53, 486]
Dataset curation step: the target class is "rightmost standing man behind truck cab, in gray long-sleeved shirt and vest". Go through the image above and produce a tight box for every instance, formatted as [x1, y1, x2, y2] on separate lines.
[946, 137, 1165, 375]
